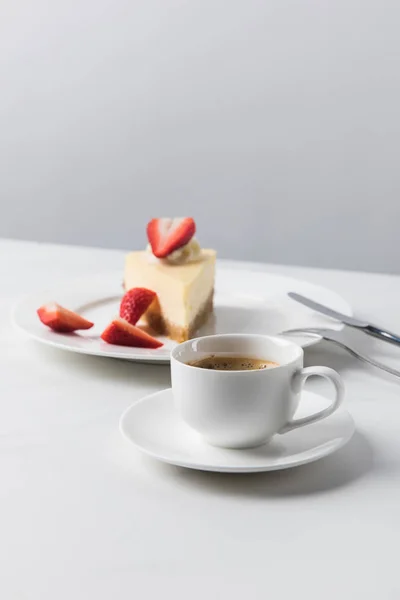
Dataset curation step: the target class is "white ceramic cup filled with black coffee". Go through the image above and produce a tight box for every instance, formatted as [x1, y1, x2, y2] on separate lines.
[171, 334, 344, 448]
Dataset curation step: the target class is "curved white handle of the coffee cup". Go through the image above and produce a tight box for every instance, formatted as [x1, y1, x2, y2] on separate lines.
[279, 367, 344, 433]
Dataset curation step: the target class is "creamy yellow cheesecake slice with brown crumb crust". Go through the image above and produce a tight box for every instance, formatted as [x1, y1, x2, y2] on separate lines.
[124, 250, 216, 342]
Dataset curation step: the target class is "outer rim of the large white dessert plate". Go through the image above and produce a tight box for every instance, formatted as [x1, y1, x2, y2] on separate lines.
[11, 268, 353, 364]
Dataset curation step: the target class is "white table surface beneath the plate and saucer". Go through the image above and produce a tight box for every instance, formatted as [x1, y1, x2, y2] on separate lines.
[0, 240, 400, 600]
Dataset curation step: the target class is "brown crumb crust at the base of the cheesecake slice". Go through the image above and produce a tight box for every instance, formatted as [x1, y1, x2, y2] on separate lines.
[144, 289, 214, 342]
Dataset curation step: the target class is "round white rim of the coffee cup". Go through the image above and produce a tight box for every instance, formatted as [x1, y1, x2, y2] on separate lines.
[171, 333, 304, 375]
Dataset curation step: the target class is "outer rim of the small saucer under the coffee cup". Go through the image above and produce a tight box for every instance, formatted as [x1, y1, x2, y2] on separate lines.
[118, 387, 356, 473]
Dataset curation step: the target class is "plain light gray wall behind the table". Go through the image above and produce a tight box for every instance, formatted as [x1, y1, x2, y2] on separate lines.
[0, 0, 400, 272]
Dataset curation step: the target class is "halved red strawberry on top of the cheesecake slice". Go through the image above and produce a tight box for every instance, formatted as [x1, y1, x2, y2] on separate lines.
[147, 217, 196, 258]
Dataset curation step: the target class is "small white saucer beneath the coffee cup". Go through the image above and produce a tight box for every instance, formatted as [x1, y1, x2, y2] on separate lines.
[120, 389, 355, 473]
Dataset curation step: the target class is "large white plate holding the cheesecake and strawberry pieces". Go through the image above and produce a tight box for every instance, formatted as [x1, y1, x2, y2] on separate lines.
[13, 265, 352, 363]
